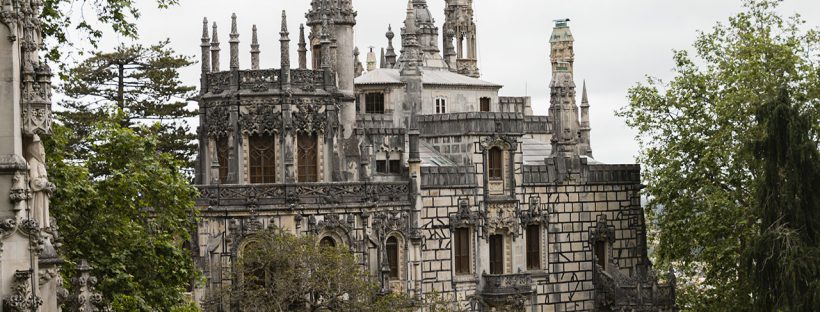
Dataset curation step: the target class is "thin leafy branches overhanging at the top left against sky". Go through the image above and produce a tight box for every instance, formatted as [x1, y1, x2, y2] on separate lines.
[41, 0, 179, 64]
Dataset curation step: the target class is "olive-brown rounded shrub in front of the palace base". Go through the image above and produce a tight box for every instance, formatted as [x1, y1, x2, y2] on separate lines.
[214, 229, 412, 311]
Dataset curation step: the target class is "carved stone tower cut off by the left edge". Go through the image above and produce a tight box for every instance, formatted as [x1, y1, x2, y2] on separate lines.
[0, 1, 62, 312]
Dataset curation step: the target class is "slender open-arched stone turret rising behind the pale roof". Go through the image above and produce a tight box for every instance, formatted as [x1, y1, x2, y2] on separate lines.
[443, 0, 481, 78]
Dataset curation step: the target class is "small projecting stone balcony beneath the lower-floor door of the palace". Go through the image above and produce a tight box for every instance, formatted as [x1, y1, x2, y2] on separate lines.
[481, 273, 534, 307]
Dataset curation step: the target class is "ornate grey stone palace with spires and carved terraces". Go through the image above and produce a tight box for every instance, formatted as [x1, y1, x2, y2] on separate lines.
[192, 0, 677, 311]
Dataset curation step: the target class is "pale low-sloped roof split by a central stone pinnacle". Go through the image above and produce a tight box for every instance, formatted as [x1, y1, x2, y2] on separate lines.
[354, 68, 501, 88]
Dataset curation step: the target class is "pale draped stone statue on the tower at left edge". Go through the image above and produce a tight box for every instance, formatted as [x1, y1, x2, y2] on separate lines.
[28, 134, 56, 228]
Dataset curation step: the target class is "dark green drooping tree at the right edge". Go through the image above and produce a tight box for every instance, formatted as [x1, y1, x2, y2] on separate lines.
[747, 88, 820, 311]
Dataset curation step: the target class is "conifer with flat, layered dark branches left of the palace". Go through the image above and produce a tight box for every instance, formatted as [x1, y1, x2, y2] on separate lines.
[58, 40, 196, 169]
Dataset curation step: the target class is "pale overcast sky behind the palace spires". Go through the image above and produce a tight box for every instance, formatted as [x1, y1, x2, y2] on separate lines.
[93, 0, 820, 163]
